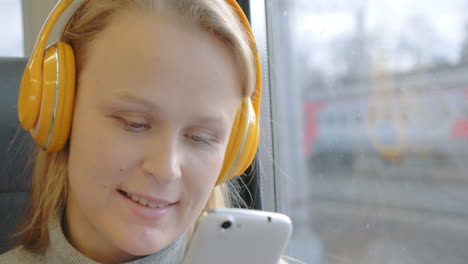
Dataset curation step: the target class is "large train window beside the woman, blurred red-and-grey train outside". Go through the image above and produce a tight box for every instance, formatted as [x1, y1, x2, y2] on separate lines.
[267, 0, 468, 264]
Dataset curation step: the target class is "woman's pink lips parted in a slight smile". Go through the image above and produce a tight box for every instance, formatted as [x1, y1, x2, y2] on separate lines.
[117, 190, 178, 220]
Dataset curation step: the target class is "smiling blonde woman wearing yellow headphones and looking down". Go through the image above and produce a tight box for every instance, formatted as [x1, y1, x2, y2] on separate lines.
[0, 0, 261, 263]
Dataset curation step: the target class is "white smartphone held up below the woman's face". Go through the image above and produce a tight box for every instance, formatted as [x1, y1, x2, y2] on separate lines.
[183, 208, 292, 264]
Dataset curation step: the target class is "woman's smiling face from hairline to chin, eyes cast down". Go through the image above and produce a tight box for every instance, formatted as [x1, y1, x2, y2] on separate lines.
[66, 9, 241, 262]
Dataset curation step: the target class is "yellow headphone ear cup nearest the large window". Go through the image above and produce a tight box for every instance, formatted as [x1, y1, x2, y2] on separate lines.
[216, 99, 259, 185]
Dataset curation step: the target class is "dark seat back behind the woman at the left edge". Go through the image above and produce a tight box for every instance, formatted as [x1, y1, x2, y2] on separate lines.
[0, 58, 32, 254]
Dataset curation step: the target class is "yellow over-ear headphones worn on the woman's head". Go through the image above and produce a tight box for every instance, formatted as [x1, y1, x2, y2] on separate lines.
[18, 0, 262, 185]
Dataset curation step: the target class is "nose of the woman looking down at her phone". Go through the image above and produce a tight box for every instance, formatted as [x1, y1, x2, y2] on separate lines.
[141, 136, 181, 184]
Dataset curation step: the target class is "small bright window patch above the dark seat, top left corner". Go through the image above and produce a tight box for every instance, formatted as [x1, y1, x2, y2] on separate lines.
[0, 0, 24, 57]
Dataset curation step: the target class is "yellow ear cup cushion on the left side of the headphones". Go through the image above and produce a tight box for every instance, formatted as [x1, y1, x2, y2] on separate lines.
[30, 42, 76, 152]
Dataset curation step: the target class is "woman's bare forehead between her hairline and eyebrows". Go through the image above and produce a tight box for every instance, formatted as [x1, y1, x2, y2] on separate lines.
[80, 12, 242, 112]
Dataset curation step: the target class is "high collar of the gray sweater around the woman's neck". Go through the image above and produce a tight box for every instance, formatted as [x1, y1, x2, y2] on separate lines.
[45, 214, 186, 264]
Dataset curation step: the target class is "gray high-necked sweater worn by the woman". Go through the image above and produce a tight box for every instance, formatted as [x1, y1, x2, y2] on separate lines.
[0, 217, 185, 264]
